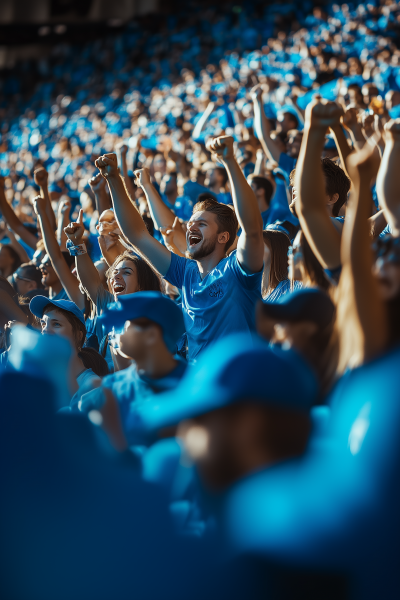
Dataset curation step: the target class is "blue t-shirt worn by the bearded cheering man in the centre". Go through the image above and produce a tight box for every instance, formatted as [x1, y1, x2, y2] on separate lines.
[165, 250, 262, 360]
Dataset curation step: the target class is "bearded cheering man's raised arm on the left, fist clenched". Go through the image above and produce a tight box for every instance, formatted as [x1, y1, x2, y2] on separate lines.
[96, 154, 171, 275]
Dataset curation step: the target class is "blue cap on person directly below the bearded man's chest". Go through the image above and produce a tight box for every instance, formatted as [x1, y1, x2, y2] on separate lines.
[99, 292, 185, 352]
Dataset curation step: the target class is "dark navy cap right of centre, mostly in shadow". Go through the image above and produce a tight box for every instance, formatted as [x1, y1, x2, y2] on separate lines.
[263, 288, 335, 327]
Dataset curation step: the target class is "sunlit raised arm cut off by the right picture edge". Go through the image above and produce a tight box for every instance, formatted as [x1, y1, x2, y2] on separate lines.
[376, 119, 400, 237]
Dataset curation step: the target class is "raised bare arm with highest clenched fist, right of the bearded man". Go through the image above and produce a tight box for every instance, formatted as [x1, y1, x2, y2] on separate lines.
[295, 100, 343, 269]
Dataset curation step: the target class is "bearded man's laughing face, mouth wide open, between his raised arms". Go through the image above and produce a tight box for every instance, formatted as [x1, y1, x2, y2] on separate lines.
[186, 211, 225, 260]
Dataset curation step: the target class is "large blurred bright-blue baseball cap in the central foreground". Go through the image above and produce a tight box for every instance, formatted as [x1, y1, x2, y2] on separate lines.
[127, 334, 318, 432]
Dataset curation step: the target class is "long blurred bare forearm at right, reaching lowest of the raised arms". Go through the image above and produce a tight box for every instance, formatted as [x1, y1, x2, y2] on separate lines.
[337, 142, 388, 371]
